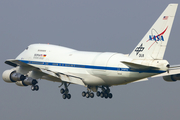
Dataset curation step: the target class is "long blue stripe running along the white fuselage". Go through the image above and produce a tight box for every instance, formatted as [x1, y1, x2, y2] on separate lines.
[20, 60, 166, 73]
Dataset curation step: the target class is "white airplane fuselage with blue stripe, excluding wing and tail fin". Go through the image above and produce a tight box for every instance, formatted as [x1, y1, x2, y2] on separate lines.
[16, 44, 167, 86]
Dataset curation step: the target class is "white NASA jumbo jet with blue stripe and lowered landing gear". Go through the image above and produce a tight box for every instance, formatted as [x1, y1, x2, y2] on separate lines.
[2, 4, 180, 99]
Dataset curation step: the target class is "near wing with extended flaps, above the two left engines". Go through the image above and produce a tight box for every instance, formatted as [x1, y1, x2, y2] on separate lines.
[5, 59, 85, 86]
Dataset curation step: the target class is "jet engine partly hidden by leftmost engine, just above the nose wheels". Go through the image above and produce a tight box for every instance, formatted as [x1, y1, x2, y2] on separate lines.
[16, 77, 38, 86]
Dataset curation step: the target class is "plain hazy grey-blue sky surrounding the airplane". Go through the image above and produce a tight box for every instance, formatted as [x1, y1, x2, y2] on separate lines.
[0, 0, 180, 120]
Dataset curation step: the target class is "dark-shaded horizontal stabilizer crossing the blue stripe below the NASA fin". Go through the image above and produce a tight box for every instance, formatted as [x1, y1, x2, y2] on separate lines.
[121, 61, 159, 70]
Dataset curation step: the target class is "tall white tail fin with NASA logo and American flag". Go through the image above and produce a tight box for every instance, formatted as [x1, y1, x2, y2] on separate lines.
[129, 4, 178, 60]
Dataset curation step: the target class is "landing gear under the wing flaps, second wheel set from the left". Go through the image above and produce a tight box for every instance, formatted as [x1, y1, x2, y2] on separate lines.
[59, 83, 71, 99]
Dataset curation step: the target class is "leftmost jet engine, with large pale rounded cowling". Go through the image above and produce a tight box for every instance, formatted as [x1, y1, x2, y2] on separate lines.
[2, 69, 26, 83]
